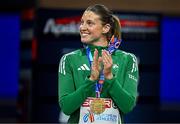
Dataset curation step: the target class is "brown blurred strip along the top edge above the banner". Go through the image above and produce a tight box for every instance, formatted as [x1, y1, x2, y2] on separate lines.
[38, 0, 180, 15]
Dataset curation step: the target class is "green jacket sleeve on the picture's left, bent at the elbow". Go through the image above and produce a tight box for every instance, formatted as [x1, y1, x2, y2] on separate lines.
[58, 55, 95, 115]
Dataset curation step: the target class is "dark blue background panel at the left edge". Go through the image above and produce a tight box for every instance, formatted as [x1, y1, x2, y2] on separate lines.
[0, 13, 20, 99]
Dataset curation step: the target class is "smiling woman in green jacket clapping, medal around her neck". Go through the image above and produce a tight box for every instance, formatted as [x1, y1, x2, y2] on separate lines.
[58, 4, 138, 124]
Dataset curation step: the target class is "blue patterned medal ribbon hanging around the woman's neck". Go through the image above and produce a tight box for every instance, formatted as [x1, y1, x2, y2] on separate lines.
[86, 35, 121, 98]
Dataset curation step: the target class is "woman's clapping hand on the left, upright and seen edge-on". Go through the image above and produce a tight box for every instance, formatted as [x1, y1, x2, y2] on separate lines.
[89, 49, 102, 81]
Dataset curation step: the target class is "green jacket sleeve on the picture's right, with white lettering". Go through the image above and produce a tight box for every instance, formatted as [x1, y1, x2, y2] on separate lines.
[106, 54, 139, 113]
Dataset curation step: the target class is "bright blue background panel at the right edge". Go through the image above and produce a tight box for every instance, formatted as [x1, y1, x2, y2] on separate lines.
[160, 17, 180, 107]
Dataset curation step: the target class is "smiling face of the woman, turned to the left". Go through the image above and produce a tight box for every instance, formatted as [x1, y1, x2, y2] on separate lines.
[79, 11, 107, 46]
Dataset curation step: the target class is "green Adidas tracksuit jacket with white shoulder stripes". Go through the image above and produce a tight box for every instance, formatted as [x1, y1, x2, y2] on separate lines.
[58, 46, 139, 123]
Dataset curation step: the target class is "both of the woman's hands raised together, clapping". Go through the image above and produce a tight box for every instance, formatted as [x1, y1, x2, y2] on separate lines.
[89, 49, 113, 81]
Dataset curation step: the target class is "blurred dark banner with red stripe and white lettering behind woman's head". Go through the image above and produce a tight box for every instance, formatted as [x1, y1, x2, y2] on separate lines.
[36, 9, 159, 39]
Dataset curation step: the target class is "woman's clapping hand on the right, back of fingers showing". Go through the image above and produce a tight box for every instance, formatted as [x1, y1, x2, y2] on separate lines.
[102, 50, 113, 79]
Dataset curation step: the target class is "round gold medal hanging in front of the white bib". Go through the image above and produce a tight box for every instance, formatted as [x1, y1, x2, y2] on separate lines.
[90, 98, 105, 114]
